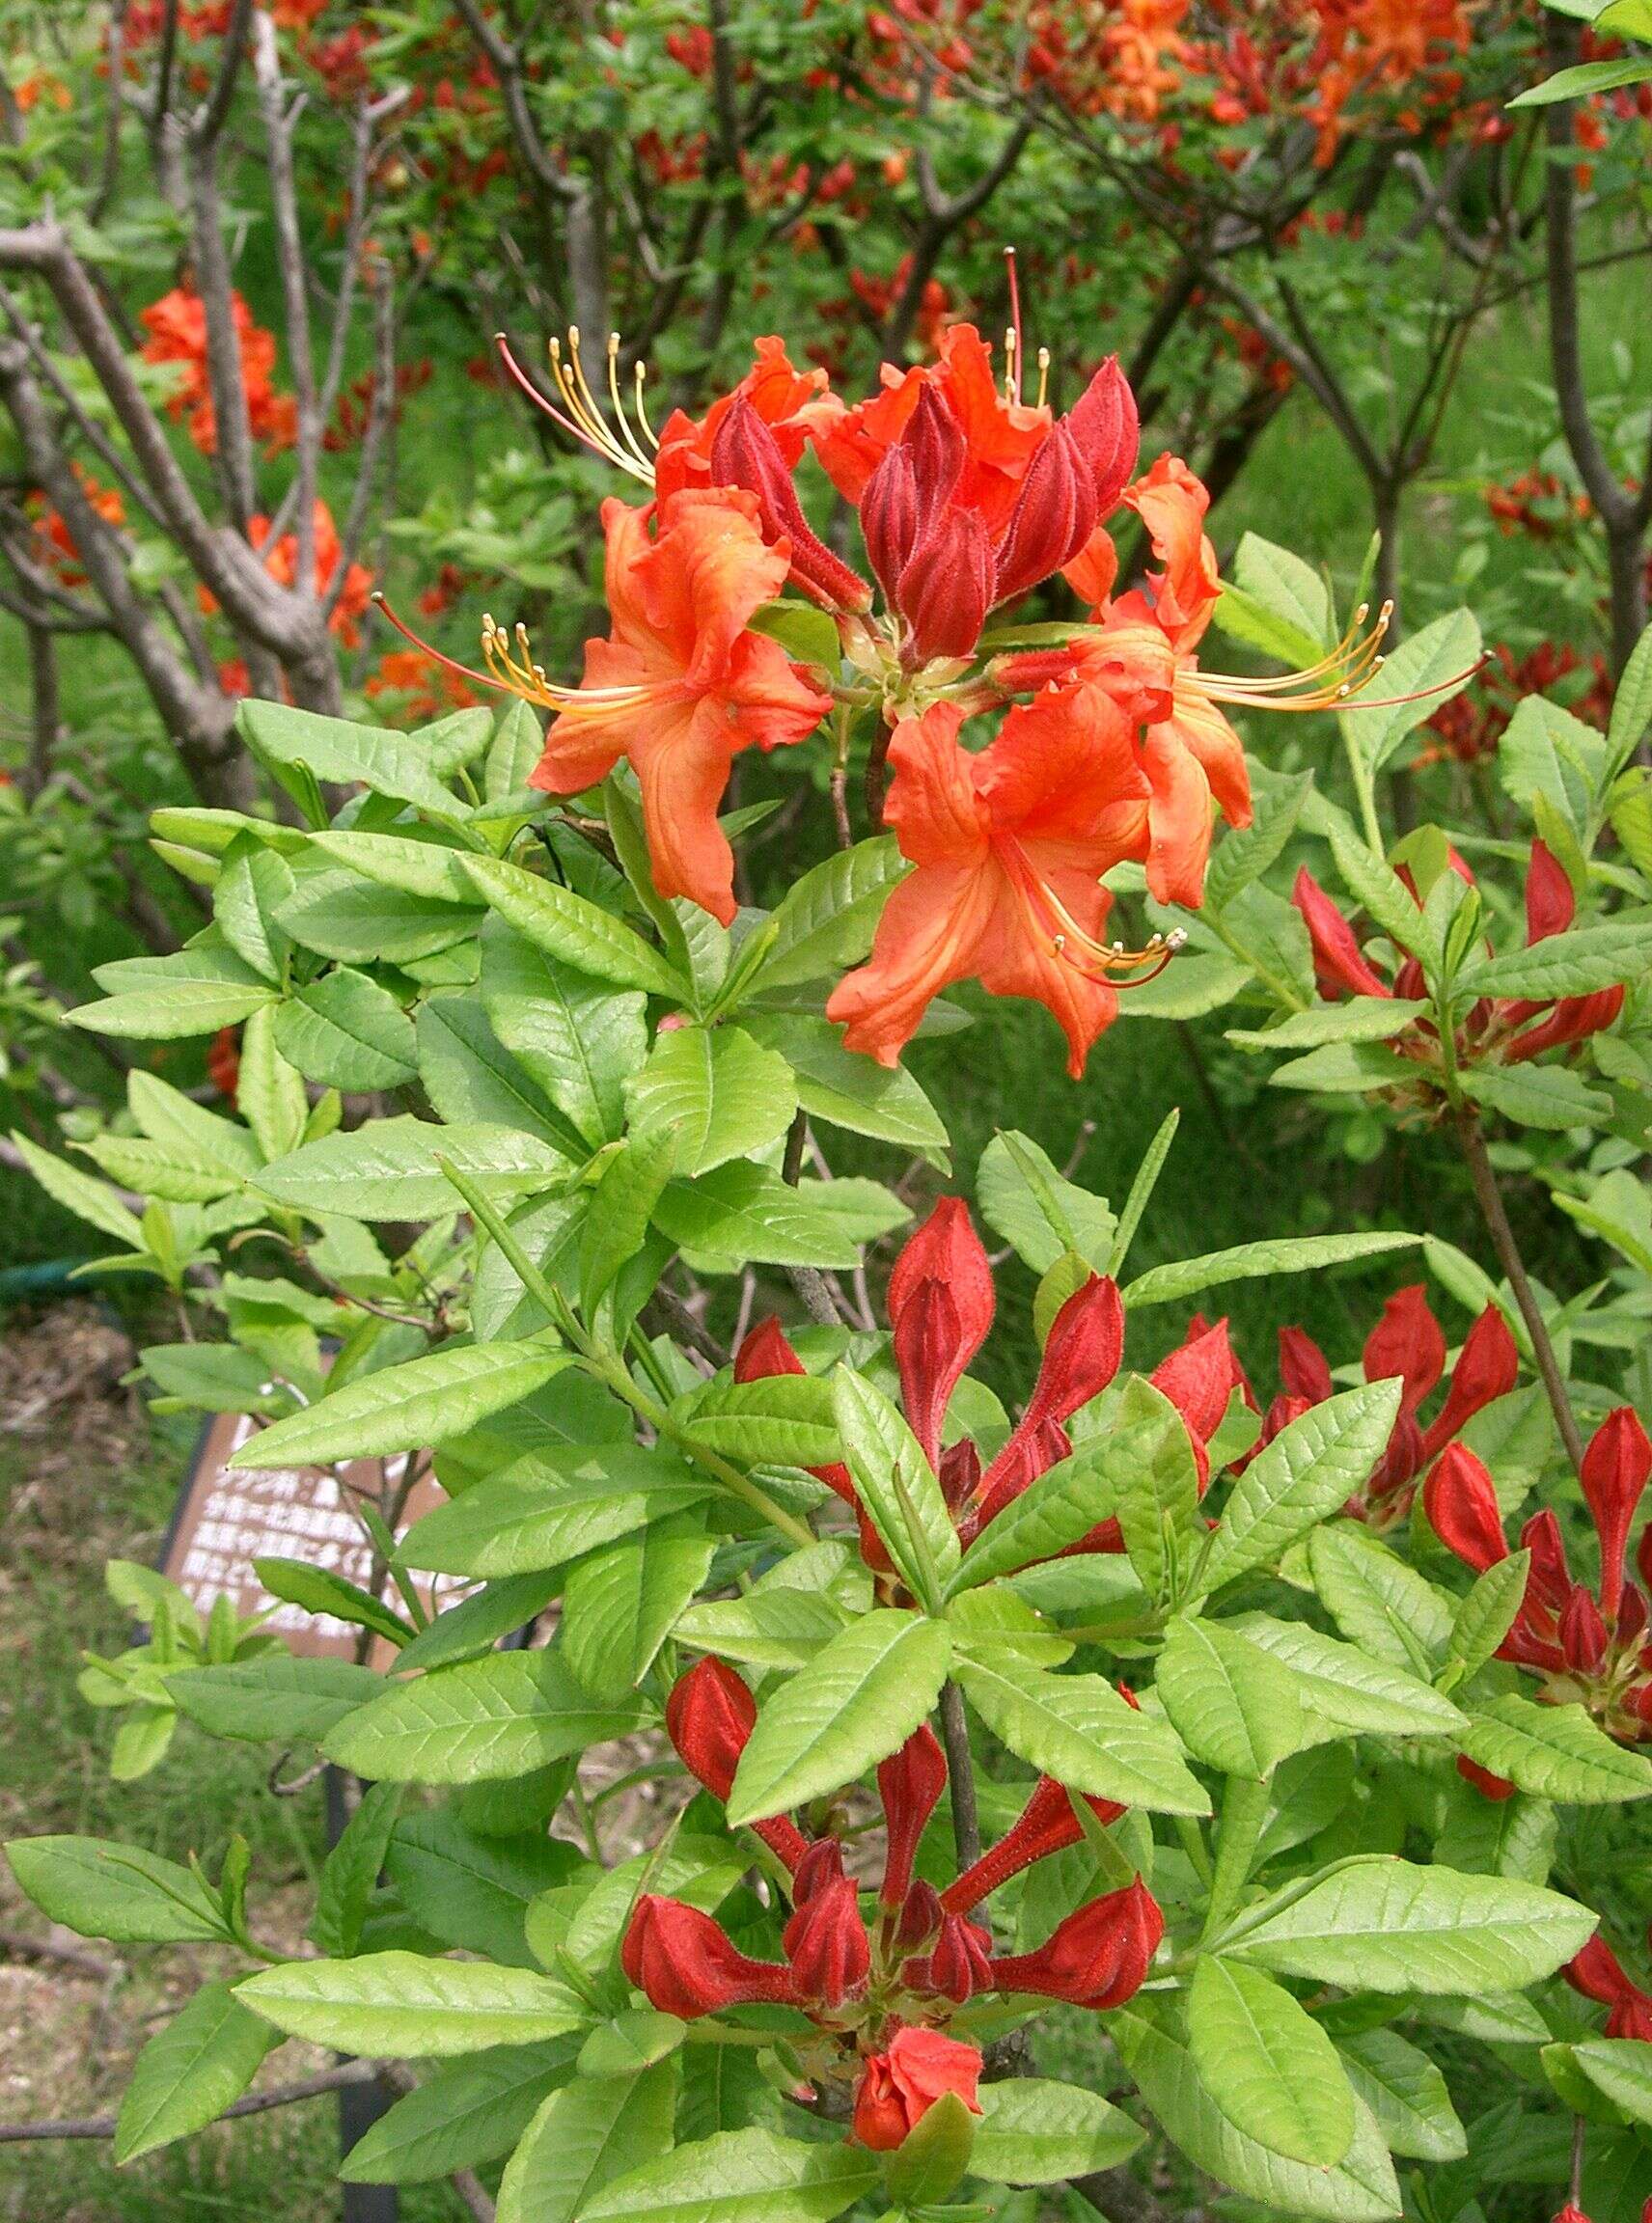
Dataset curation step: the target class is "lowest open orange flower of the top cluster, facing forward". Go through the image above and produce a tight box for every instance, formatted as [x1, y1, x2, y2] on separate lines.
[827, 685, 1165, 1078]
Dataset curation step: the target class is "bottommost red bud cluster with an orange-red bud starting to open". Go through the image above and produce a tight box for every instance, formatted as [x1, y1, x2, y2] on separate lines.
[620, 1656, 1165, 2150]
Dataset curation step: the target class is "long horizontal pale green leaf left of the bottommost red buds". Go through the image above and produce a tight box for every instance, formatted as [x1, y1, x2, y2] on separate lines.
[235, 1952, 590, 2061]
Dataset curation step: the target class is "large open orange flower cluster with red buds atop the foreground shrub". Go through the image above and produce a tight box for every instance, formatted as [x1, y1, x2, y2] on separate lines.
[377, 324, 1422, 1076]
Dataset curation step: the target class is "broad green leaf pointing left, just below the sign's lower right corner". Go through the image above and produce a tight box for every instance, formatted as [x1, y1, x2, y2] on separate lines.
[324, 1652, 643, 1787]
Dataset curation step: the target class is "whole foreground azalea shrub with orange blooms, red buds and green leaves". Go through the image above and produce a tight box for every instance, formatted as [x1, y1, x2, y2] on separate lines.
[9, 278, 1652, 2223]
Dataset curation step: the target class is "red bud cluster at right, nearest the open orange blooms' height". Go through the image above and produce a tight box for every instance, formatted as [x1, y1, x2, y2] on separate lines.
[1292, 840, 1623, 1081]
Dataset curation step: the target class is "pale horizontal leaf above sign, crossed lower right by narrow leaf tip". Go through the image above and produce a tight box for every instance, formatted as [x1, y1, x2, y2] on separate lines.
[256, 1118, 567, 1221]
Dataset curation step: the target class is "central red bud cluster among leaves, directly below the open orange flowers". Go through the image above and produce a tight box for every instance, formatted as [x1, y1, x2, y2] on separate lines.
[733, 1196, 1243, 1601]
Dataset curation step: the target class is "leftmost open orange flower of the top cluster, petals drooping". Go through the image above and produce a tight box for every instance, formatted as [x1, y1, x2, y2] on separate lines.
[534, 491, 832, 924]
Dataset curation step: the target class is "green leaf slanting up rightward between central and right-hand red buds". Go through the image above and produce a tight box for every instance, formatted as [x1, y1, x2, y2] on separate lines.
[1198, 1381, 1401, 1592]
